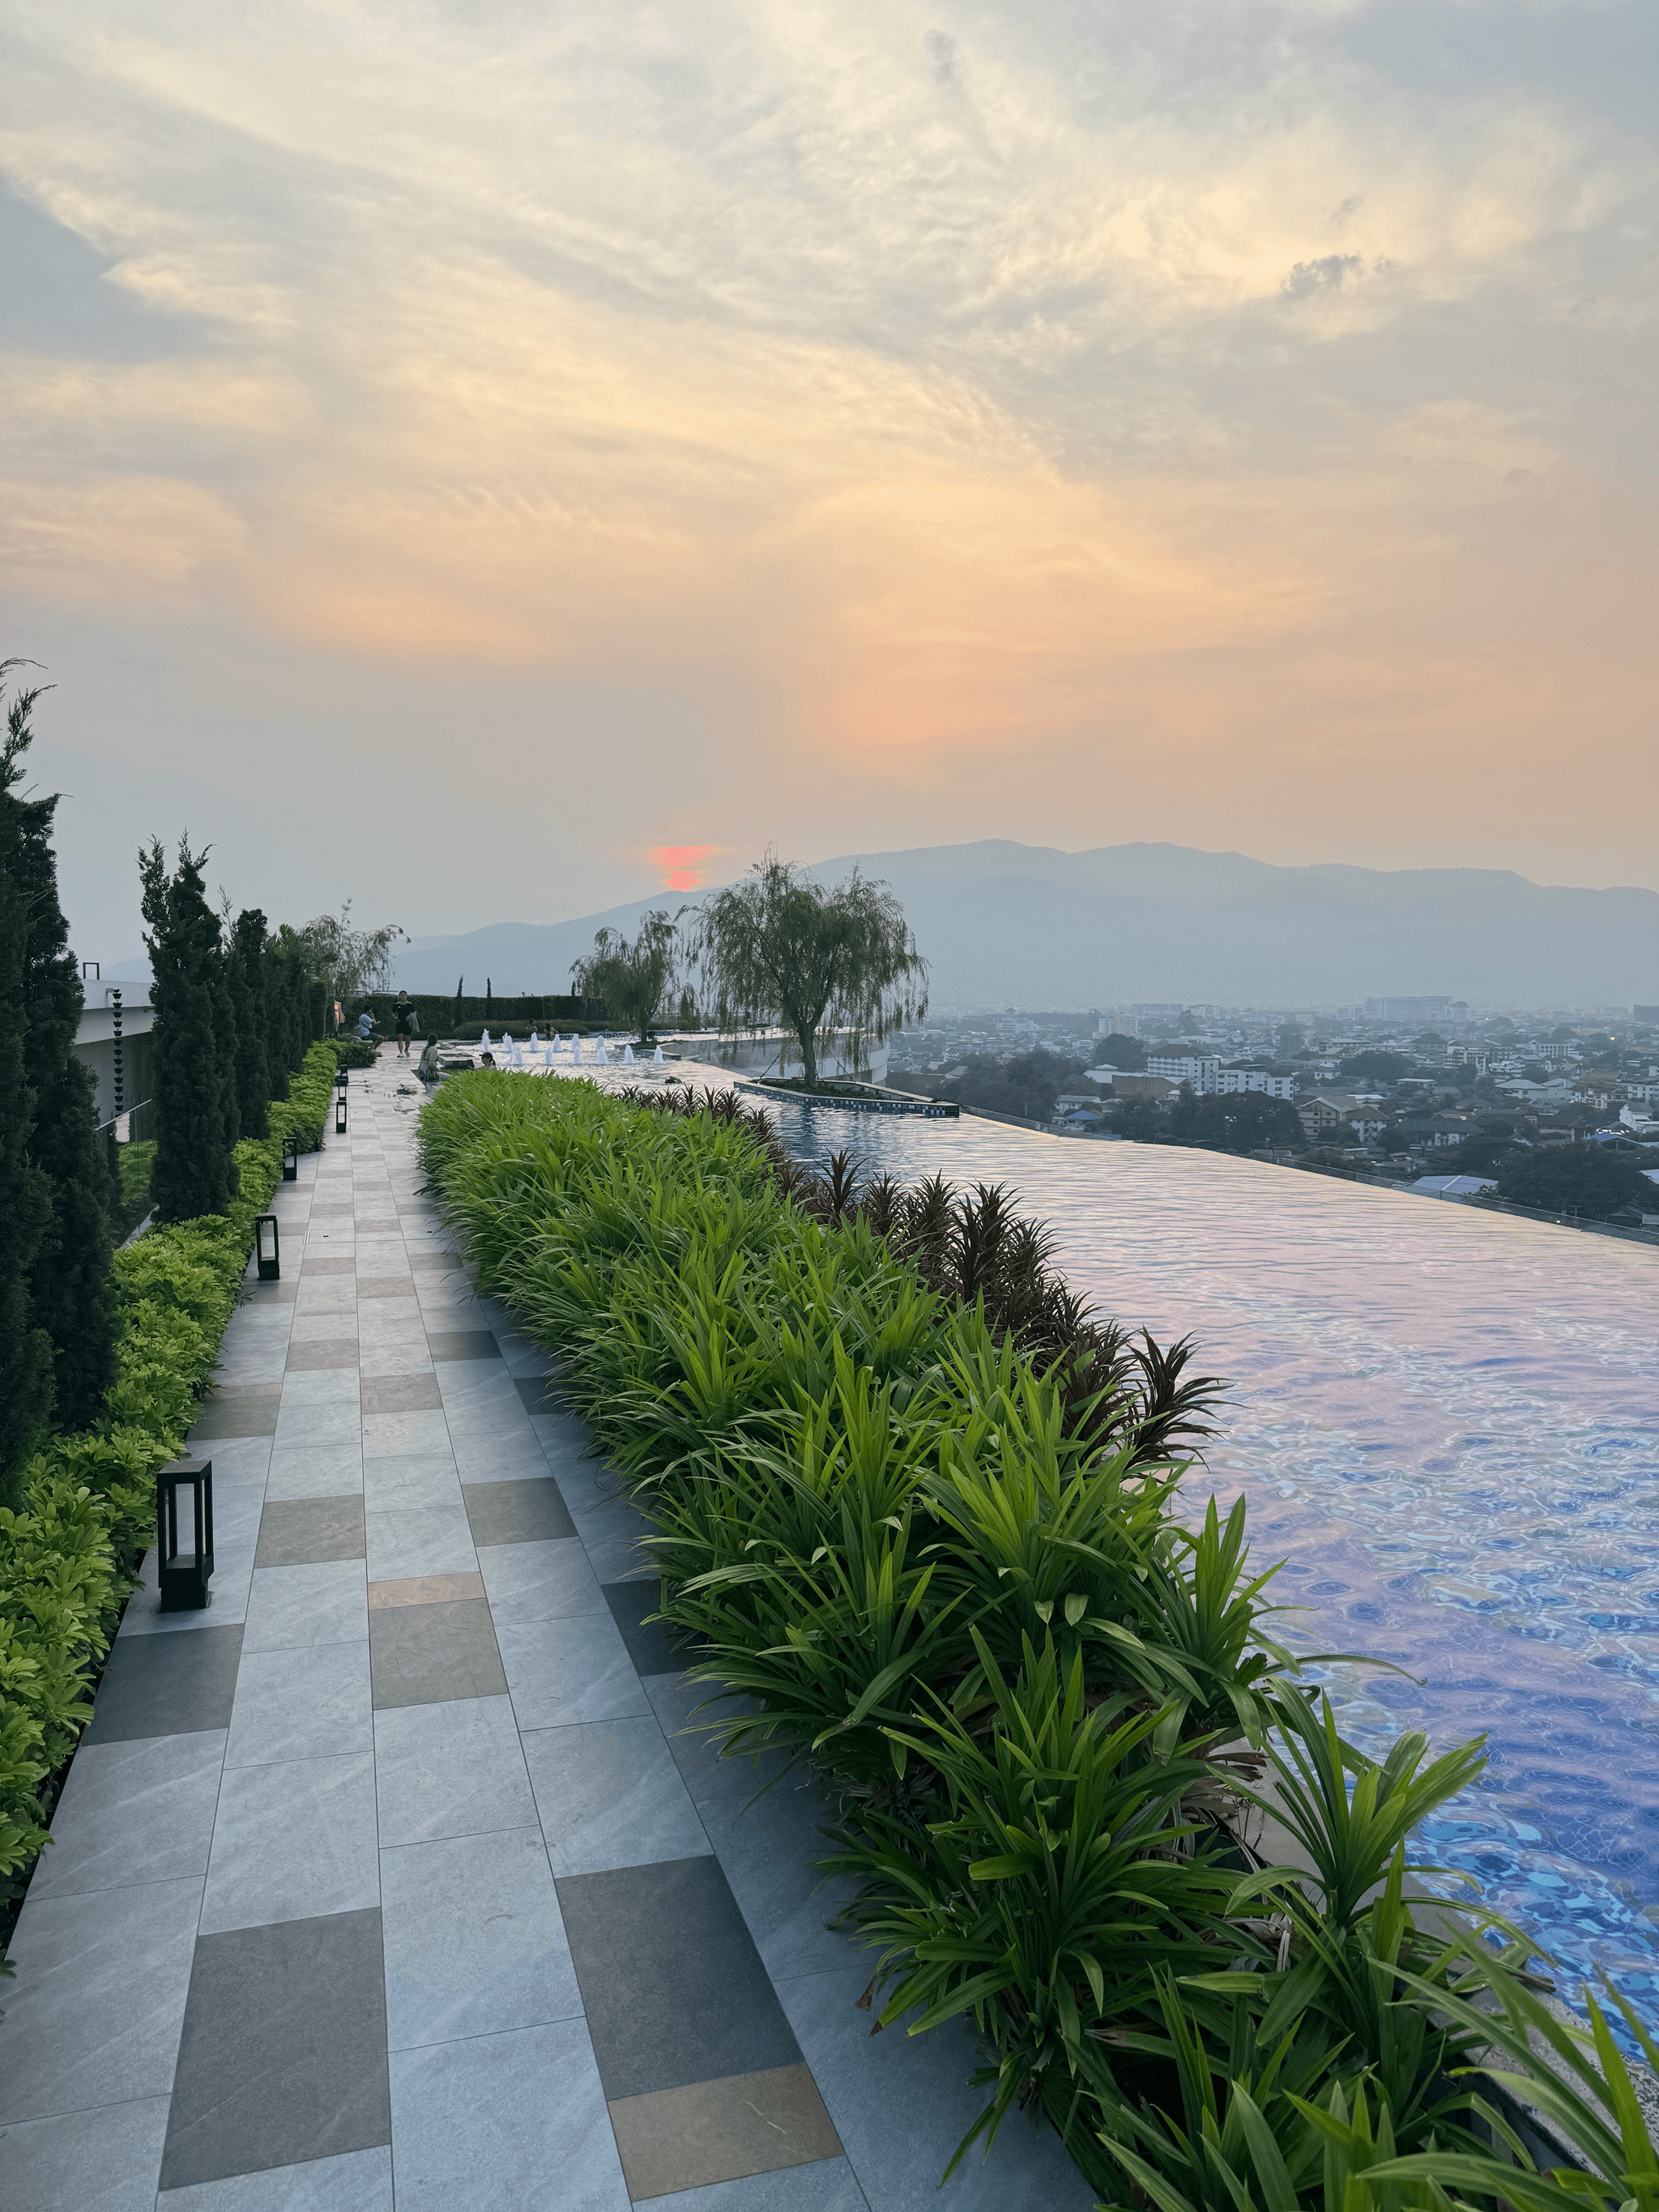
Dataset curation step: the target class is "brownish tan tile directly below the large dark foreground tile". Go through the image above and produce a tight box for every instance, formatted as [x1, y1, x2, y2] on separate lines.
[611, 2064, 841, 2203]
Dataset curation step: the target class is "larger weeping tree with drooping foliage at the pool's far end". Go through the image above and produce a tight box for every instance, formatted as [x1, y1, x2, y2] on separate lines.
[690, 851, 927, 1084]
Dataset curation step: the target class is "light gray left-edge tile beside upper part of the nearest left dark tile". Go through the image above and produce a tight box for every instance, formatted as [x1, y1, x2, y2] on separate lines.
[0, 1880, 201, 2124]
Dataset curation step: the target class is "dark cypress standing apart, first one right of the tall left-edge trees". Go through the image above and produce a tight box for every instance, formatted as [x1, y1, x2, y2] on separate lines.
[139, 836, 230, 1221]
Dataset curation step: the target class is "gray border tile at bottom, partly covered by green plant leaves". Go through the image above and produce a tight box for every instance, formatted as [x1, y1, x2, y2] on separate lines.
[778, 1955, 1097, 2212]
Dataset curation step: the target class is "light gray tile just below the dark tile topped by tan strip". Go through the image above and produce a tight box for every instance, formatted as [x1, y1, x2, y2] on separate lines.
[373, 1697, 535, 1849]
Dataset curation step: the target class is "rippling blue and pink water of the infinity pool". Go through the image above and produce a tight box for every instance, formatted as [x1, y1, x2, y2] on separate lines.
[776, 1108, 1659, 2027]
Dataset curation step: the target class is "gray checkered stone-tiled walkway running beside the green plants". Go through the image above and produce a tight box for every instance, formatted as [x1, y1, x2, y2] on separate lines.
[0, 1053, 1093, 2212]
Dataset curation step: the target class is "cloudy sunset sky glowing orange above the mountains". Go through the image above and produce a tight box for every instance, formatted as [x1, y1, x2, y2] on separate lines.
[0, 0, 1659, 960]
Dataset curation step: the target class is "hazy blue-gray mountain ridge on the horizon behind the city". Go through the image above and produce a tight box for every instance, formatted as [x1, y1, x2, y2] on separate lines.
[399, 838, 1659, 1013]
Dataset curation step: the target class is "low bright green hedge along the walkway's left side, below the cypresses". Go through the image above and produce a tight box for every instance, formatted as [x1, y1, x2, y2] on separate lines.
[0, 1044, 334, 1898]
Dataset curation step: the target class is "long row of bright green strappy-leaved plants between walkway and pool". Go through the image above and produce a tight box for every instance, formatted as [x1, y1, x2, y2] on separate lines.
[420, 1071, 1659, 2212]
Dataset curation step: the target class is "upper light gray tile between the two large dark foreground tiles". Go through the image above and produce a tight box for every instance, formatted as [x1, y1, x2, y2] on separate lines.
[381, 1827, 582, 2051]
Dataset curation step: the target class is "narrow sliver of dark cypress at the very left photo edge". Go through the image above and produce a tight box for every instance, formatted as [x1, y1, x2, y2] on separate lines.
[0, 854, 51, 1507]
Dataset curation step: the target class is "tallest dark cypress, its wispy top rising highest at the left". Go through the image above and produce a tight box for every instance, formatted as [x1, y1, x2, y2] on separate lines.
[0, 663, 115, 1429]
